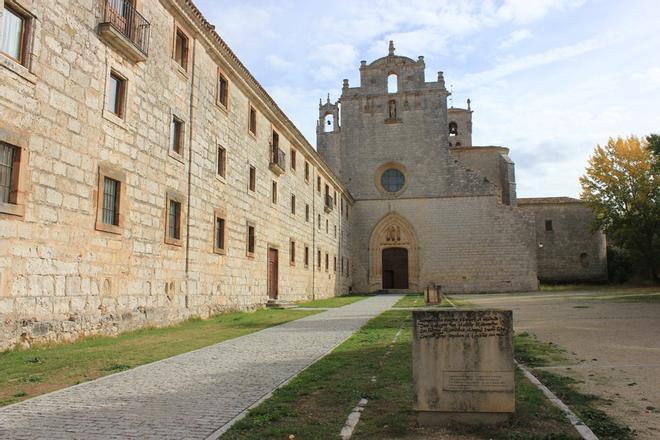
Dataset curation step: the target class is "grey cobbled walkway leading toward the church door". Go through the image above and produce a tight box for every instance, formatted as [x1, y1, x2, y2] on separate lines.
[0, 295, 400, 439]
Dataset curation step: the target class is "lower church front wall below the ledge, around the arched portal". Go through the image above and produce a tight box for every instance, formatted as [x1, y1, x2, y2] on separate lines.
[351, 196, 538, 293]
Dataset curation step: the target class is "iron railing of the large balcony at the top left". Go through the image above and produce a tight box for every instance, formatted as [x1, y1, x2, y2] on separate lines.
[103, 0, 151, 55]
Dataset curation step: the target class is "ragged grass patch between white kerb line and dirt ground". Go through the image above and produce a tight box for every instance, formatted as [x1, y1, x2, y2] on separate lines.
[514, 332, 634, 440]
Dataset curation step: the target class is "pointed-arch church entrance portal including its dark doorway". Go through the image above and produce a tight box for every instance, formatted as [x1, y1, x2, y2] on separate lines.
[369, 212, 419, 292]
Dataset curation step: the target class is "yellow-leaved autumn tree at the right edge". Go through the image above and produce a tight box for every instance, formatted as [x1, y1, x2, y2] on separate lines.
[580, 136, 660, 279]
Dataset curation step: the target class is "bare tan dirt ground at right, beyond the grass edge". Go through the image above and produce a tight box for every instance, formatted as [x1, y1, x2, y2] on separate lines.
[455, 291, 660, 440]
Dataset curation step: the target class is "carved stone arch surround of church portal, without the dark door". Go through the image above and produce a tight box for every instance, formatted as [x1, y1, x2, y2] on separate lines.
[369, 213, 419, 289]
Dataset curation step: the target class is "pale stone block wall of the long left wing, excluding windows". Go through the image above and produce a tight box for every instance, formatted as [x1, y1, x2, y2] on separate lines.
[0, 0, 351, 349]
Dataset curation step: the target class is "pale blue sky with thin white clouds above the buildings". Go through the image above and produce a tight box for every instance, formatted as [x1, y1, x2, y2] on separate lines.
[195, 0, 660, 197]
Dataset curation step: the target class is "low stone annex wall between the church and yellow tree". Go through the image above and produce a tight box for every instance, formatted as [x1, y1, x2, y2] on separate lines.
[518, 197, 607, 282]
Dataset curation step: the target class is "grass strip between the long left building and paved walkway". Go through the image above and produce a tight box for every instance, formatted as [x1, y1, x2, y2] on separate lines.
[0, 309, 317, 406]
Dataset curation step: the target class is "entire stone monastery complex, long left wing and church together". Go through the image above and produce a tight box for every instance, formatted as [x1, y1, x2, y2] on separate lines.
[0, 0, 604, 350]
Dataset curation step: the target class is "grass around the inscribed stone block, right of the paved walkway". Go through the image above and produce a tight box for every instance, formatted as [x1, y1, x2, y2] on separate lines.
[223, 310, 579, 439]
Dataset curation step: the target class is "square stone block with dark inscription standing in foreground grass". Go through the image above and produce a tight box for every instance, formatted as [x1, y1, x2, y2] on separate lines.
[412, 309, 515, 425]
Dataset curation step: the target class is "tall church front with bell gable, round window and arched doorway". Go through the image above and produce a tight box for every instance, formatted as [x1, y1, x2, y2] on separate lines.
[317, 46, 537, 293]
